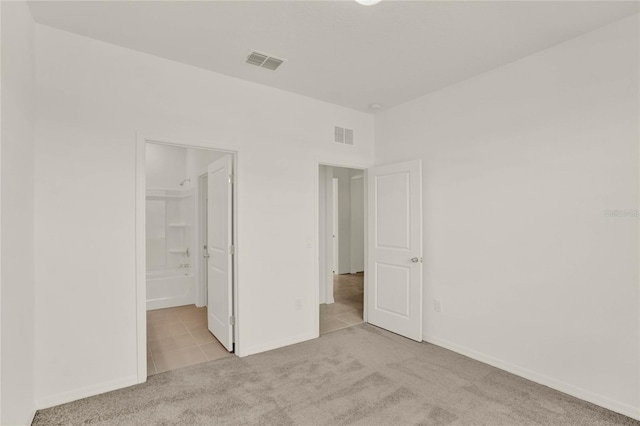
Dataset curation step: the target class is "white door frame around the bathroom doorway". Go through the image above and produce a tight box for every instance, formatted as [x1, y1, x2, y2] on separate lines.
[135, 133, 242, 383]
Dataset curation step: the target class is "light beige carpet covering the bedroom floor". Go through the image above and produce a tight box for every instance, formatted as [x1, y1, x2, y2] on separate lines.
[33, 324, 640, 425]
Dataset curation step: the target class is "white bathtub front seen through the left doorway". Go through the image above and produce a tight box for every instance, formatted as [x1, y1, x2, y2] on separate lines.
[147, 268, 196, 311]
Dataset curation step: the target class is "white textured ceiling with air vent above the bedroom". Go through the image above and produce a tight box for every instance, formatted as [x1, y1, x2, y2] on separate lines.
[30, 0, 638, 111]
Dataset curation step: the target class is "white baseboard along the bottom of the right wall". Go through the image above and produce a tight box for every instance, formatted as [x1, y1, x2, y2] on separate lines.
[422, 335, 640, 420]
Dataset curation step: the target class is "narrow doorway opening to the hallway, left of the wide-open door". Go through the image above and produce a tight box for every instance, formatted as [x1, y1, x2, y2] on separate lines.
[318, 165, 366, 335]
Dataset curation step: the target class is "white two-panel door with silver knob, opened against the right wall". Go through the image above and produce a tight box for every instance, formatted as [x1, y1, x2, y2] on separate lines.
[367, 160, 422, 341]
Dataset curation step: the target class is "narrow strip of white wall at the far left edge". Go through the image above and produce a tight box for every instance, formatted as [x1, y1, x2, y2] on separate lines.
[0, 2, 36, 424]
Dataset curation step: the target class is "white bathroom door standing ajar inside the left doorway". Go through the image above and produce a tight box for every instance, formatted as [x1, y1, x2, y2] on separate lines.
[207, 155, 234, 351]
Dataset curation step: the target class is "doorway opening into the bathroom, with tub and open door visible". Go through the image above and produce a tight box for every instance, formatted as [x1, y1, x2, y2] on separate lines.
[137, 140, 236, 381]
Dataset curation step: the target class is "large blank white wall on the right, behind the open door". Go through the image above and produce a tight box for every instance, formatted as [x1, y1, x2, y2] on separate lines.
[375, 15, 640, 418]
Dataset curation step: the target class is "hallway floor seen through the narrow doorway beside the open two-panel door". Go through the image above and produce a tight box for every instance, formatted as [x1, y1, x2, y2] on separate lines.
[320, 272, 364, 334]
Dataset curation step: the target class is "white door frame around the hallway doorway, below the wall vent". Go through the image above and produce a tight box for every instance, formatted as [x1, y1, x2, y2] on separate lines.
[313, 158, 373, 337]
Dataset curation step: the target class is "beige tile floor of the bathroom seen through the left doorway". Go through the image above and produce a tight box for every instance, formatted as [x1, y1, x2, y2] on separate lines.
[147, 305, 231, 376]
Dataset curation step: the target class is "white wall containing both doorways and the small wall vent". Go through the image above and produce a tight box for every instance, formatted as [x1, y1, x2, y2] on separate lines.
[35, 26, 373, 407]
